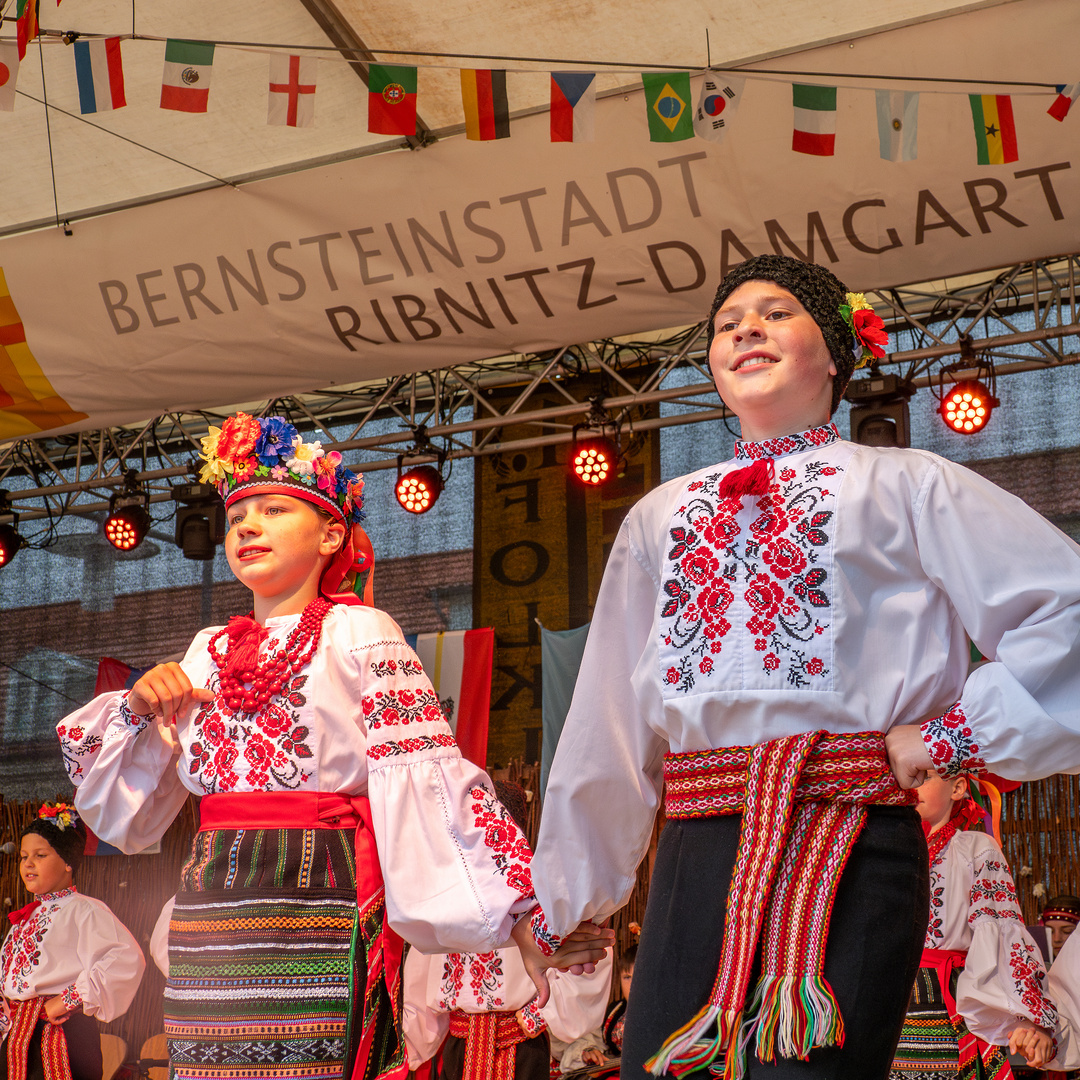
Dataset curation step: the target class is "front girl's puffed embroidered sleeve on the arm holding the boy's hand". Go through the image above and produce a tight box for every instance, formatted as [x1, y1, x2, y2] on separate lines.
[353, 612, 536, 953]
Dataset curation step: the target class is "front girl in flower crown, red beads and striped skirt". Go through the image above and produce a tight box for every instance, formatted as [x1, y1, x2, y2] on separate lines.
[57, 413, 606, 1080]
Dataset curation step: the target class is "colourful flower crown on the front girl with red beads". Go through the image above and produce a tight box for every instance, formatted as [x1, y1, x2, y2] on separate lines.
[199, 413, 364, 525]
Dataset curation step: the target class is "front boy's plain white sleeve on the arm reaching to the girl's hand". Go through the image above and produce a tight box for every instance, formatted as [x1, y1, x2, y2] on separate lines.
[532, 512, 667, 937]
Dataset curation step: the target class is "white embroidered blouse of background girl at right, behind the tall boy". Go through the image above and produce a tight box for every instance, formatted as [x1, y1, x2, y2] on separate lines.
[926, 833, 1057, 1045]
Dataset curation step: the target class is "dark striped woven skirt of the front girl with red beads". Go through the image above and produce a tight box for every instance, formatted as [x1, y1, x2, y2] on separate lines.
[164, 828, 403, 1080]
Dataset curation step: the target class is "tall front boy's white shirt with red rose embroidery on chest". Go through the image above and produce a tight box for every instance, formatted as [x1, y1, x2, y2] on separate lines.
[532, 426, 1080, 936]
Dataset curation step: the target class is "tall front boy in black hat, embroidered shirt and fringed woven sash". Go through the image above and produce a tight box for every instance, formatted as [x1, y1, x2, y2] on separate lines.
[524, 255, 1080, 1080]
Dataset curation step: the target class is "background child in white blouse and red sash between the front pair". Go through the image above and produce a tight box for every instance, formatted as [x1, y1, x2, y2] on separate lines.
[404, 780, 611, 1080]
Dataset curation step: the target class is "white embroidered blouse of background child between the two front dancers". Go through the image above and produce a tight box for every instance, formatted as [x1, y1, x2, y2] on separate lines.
[404, 948, 612, 1069]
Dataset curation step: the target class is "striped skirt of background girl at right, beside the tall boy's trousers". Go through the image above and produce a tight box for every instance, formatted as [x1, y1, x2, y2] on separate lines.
[889, 968, 1013, 1080]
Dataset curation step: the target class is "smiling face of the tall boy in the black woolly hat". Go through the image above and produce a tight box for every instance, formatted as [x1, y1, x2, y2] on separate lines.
[708, 281, 836, 441]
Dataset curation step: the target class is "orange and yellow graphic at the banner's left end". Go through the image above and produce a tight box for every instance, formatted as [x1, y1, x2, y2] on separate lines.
[0, 267, 86, 440]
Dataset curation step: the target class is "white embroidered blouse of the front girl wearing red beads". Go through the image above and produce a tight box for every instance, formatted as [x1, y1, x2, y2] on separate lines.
[57, 605, 536, 951]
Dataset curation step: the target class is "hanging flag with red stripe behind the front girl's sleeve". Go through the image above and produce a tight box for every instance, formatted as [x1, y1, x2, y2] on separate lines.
[405, 626, 495, 769]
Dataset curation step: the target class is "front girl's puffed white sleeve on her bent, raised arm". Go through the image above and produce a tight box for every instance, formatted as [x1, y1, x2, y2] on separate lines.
[56, 631, 211, 854]
